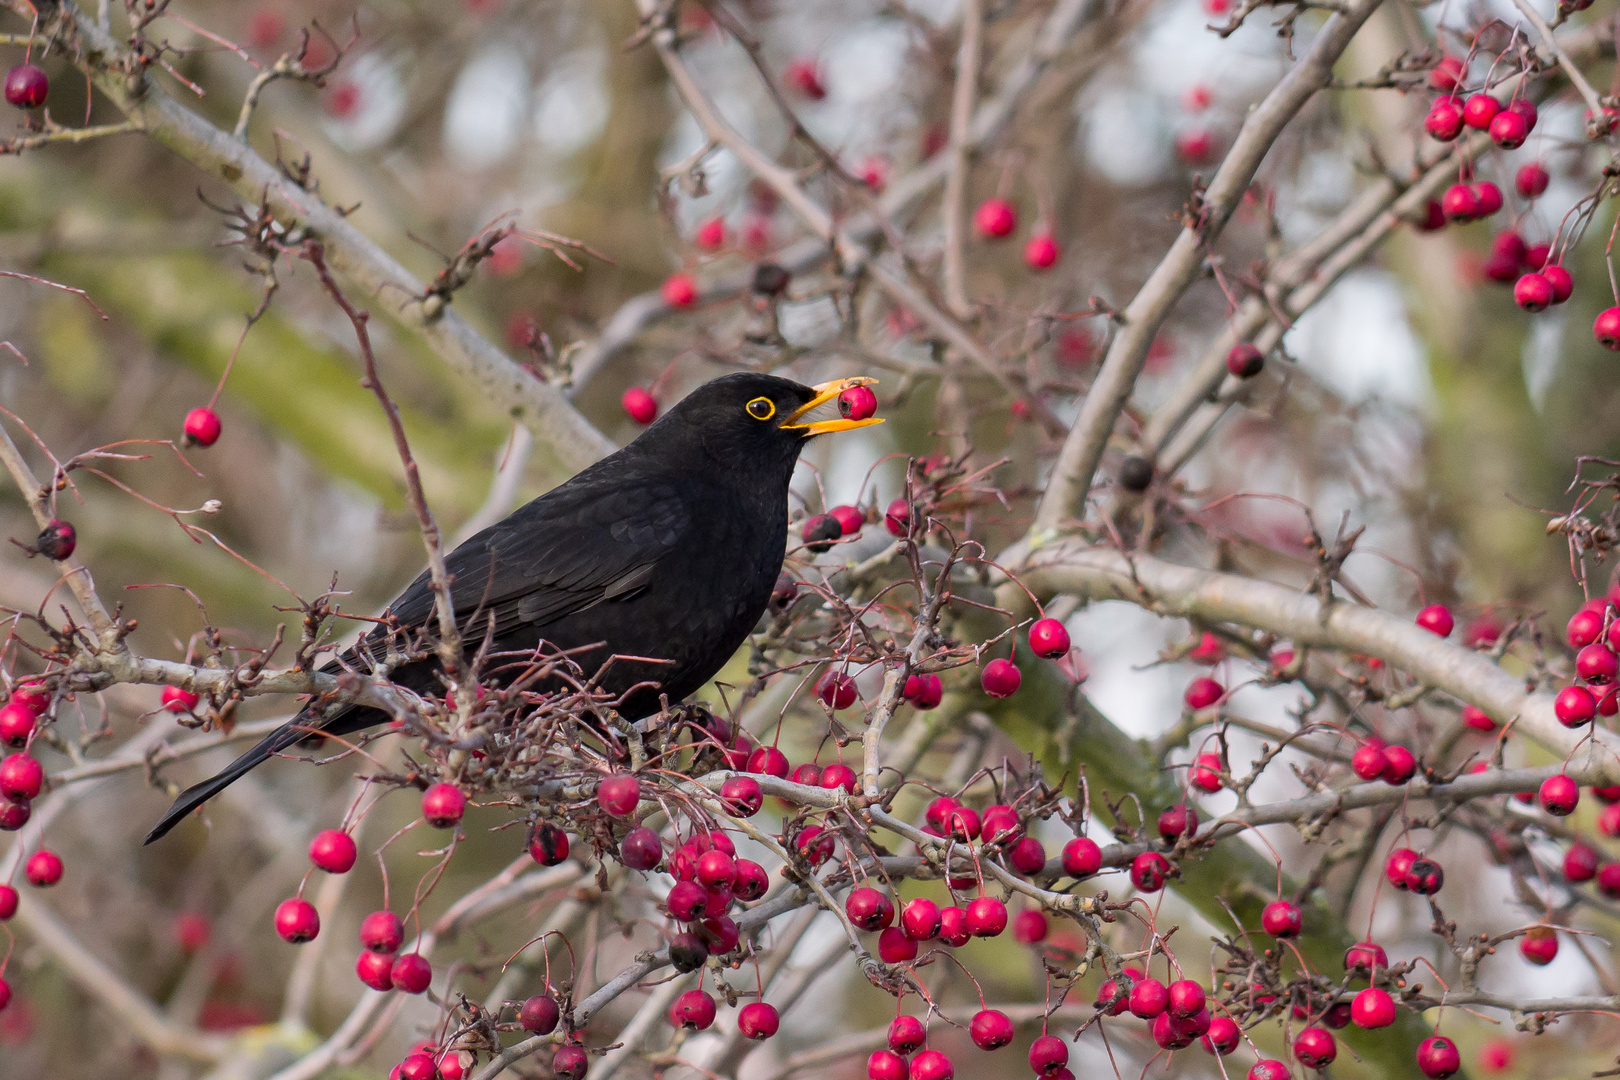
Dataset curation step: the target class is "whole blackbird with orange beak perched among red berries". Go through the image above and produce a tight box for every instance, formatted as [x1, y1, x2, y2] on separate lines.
[146, 374, 881, 844]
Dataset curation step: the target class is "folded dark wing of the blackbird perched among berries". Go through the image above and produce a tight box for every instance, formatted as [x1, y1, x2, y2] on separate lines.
[364, 478, 692, 654]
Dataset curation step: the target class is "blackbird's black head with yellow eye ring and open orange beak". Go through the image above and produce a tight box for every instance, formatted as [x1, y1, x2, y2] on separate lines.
[645, 372, 883, 471]
